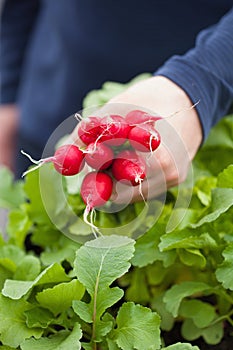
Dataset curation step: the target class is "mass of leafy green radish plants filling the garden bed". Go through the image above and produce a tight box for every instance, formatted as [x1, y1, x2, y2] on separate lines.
[0, 76, 233, 350]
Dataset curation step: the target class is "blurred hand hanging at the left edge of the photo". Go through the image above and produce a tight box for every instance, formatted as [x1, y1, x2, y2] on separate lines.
[0, 104, 18, 171]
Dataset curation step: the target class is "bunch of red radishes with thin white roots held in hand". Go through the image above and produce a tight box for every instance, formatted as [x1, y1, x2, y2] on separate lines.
[22, 110, 161, 235]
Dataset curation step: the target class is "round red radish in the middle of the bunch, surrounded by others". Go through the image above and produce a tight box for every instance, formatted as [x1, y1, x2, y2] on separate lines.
[85, 142, 114, 170]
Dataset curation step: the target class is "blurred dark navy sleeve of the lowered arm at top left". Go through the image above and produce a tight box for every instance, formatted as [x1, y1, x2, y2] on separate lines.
[0, 0, 39, 103]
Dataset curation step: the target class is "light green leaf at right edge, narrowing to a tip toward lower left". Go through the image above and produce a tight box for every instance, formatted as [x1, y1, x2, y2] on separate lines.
[191, 188, 233, 228]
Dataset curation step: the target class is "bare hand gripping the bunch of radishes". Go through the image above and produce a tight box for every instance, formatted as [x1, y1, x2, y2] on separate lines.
[101, 76, 202, 204]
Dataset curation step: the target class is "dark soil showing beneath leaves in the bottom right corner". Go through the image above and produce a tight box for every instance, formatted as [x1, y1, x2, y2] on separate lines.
[162, 324, 233, 350]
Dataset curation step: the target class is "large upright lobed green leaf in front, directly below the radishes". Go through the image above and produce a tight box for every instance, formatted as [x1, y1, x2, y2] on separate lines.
[73, 235, 134, 339]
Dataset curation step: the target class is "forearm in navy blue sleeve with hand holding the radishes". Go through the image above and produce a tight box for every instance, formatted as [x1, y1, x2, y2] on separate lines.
[96, 10, 233, 203]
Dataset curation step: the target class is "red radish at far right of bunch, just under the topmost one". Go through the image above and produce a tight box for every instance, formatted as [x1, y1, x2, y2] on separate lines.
[128, 124, 161, 152]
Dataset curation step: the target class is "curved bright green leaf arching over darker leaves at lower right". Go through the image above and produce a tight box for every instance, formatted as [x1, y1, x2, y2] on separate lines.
[163, 281, 211, 317]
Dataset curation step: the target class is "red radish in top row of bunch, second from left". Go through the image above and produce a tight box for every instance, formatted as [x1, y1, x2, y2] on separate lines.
[100, 114, 130, 146]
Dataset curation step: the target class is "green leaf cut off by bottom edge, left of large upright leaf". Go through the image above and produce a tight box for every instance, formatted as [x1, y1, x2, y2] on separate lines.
[21, 323, 82, 350]
